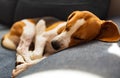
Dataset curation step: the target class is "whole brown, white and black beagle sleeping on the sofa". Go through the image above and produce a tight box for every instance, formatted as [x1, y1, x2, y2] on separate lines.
[2, 11, 120, 77]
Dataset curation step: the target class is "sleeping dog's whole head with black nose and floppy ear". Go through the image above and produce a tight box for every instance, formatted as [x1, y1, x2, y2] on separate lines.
[51, 11, 120, 50]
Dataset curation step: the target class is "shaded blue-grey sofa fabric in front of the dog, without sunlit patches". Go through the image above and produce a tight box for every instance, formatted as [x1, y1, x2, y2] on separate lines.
[17, 41, 120, 78]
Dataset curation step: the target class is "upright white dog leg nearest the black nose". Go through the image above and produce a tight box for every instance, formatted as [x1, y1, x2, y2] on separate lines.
[31, 20, 47, 60]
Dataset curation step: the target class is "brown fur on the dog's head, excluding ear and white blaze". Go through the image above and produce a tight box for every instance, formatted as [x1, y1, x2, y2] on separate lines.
[66, 11, 103, 46]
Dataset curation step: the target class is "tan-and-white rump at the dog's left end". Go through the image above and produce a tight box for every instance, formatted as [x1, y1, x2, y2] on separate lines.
[2, 21, 25, 50]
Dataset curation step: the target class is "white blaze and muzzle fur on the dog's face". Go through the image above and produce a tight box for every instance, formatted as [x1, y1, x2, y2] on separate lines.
[53, 19, 85, 49]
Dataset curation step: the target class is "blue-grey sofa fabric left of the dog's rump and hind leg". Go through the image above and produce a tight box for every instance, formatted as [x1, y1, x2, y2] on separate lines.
[0, 25, 16, 78]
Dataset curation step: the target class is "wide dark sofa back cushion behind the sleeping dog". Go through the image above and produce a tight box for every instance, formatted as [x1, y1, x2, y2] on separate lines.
[15, 0, 109, 21]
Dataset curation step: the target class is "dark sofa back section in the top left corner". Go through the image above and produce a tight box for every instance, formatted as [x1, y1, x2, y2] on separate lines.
[0, 0, 17, 24]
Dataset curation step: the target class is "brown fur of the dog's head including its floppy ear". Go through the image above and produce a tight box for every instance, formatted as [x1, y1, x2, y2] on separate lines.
[65, 11, 120, 46]
